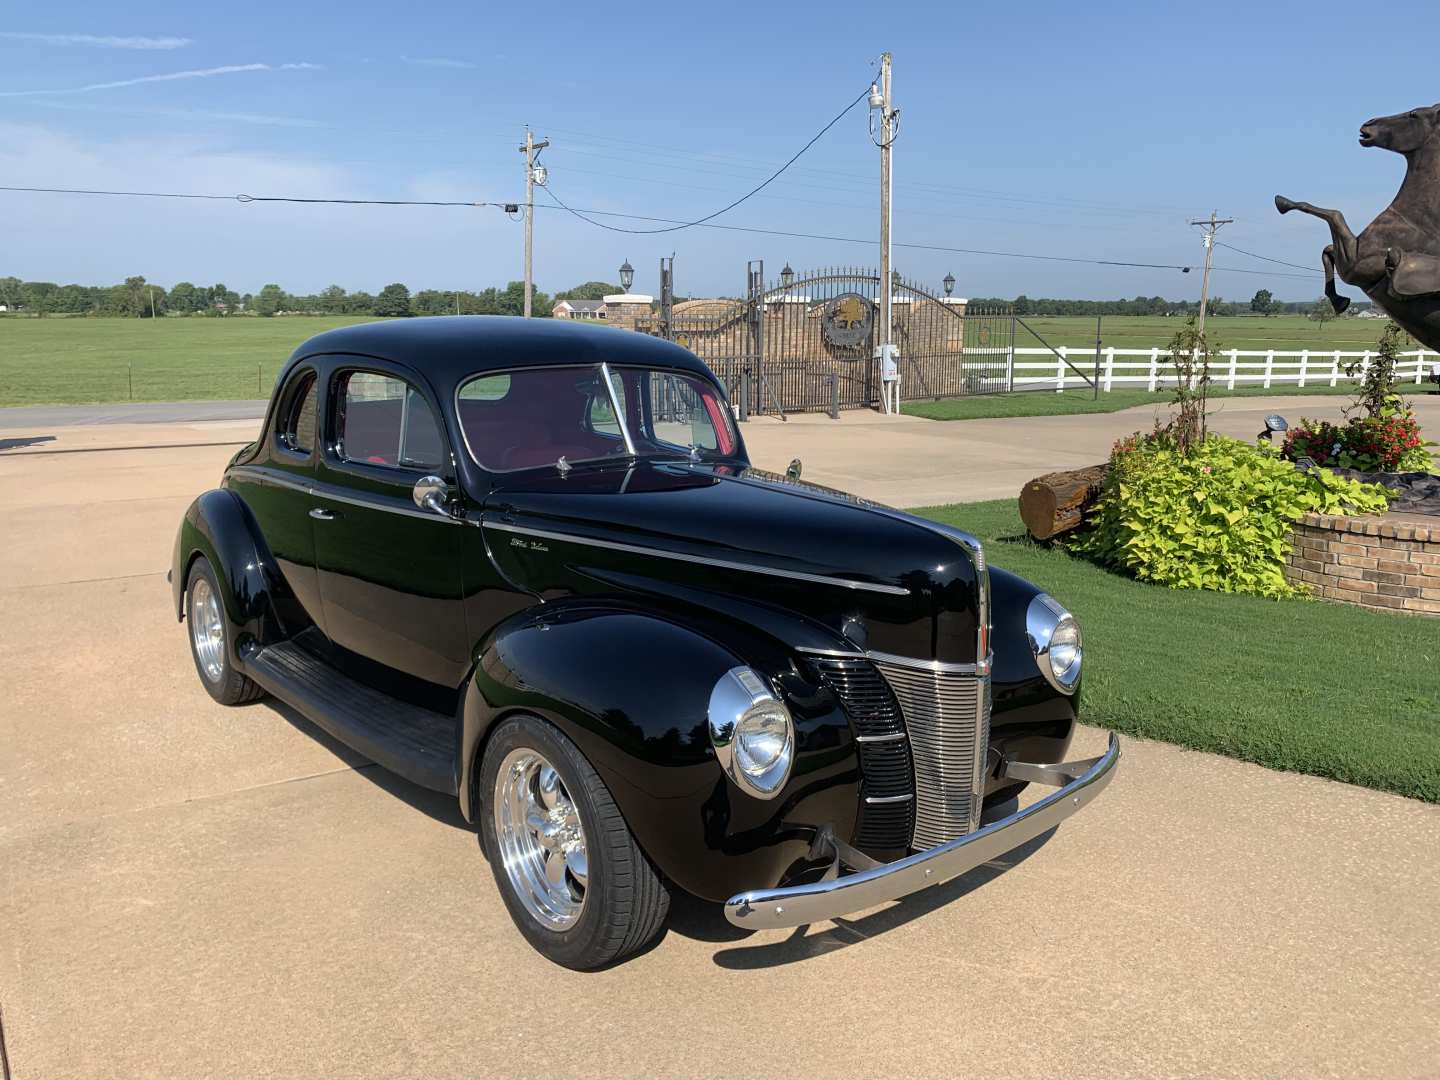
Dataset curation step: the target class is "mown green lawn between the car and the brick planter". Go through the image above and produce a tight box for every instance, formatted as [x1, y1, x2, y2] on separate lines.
[914, 500, 1440, 802]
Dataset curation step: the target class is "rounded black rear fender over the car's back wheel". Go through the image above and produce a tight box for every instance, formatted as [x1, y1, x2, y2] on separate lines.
[170, 488, 278, 662]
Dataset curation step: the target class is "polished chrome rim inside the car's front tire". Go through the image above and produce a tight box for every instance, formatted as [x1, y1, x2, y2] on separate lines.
[491, 747, 590, 930]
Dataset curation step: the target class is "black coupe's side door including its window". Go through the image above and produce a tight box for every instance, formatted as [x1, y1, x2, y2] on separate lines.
[312, 361, 469, 688]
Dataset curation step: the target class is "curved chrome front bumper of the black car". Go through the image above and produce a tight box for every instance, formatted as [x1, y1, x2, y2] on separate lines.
[724, 732, 1120, 930]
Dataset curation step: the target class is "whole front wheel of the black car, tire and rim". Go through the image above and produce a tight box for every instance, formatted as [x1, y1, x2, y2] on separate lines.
[480, 716, 670, 971]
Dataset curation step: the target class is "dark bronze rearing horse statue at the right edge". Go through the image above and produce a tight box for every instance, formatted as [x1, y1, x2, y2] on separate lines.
[1274, 105, 1440, 348]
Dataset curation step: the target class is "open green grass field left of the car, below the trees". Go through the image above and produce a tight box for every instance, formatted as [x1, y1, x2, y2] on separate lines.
[0, 317, 383, 406]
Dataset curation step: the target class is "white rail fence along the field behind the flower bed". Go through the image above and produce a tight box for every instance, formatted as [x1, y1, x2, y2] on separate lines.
[996, 346, 1440, 392]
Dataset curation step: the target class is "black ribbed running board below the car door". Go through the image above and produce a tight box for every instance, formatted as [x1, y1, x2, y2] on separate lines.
[245, 641, 455, 795]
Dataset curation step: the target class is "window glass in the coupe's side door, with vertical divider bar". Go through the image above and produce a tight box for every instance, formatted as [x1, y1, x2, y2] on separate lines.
[336, 372, 445, 469]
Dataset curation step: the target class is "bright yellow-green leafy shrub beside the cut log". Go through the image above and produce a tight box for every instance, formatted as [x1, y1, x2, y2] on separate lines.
[1071, 432, 1388, 598]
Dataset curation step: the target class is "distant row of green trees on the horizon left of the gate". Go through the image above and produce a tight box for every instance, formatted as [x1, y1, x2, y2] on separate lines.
[0, 275, 624, 318]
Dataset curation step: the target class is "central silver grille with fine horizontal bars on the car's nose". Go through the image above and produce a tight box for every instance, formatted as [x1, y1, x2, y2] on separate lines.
[876, 661, 991, 851]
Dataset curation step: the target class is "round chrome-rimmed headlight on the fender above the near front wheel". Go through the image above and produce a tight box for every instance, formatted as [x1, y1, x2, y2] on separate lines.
[710, 668, 795, 799]
